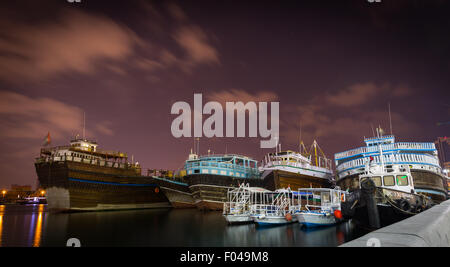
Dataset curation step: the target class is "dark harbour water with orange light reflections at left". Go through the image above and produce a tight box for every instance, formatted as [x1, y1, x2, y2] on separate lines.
[0, 205, 367, 247]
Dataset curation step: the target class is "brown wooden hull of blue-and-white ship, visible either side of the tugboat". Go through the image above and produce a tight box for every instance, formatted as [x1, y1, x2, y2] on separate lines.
[337, 169, 447, 203]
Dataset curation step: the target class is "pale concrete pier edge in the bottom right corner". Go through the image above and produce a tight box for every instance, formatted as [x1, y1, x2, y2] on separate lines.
[341, 200, 450, 247]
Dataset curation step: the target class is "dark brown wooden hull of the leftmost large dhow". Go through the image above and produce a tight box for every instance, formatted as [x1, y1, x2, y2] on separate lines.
[35, 161, 170, 214]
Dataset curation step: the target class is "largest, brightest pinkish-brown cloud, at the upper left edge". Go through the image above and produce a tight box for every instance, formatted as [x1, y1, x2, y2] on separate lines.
[0, 10, 142, 81]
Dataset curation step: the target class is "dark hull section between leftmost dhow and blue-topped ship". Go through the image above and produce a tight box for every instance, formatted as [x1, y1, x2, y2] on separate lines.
[154, 177, 196, 209]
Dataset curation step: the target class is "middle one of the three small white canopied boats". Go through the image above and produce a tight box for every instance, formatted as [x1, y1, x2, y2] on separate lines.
[250, 188, 300, 225]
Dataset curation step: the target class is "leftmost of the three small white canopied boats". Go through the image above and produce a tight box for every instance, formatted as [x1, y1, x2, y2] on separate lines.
[223, 184, 270, 224]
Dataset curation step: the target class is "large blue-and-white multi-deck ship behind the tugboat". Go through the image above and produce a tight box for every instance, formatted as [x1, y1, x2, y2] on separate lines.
[334, 129, 447, 203]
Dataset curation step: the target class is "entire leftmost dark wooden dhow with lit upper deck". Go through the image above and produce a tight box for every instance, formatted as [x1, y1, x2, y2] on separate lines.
[35, 138, 170, 211]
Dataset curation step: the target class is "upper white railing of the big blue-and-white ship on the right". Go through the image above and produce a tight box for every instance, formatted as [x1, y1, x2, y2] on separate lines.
[334, 142, 436, 160]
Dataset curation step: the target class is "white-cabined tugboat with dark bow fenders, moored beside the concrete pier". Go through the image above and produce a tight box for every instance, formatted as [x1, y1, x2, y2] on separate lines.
[342, 131, 433, 228]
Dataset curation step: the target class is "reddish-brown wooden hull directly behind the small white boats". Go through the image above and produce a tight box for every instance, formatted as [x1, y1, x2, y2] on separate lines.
[264, 170, 331, 191]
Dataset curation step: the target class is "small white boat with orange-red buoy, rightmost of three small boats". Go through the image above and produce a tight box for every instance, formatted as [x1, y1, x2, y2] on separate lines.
[295, 188, 346, 227]
